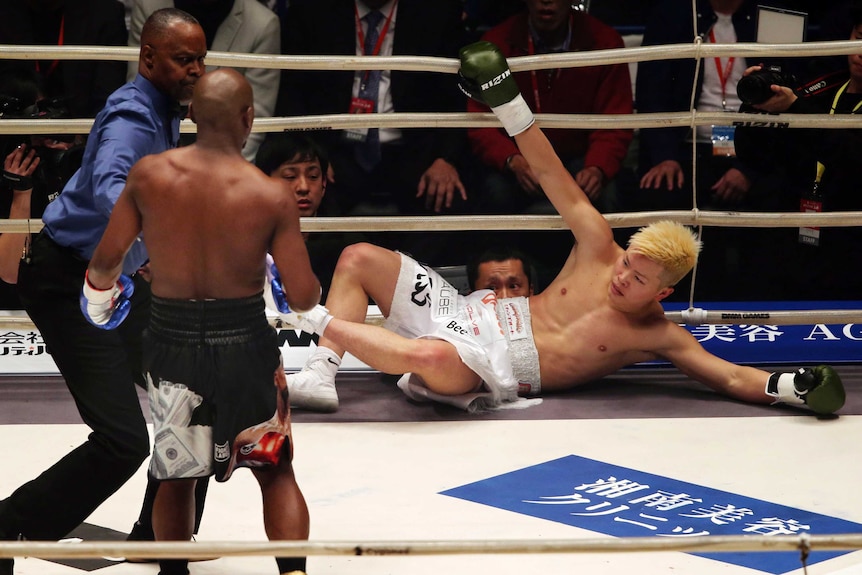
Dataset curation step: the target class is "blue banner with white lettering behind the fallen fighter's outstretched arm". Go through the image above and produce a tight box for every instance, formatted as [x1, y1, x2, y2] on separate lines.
[656, 301, 862, 365]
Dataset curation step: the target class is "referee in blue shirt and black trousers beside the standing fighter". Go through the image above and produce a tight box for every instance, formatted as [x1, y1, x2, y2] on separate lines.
[0, 9, 206, 573]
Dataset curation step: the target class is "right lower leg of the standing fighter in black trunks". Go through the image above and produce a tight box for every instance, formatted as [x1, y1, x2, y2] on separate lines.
[252, 462, 309, 573]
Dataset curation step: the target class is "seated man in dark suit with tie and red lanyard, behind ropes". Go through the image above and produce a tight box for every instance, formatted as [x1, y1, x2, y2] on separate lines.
[278, 0, 467, 259]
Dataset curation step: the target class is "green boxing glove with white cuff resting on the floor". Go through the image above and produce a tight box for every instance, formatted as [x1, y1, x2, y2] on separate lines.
[766, 365, 845, 415]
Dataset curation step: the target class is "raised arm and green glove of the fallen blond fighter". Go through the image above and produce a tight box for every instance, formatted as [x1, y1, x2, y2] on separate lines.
[460, 41, 614, 253]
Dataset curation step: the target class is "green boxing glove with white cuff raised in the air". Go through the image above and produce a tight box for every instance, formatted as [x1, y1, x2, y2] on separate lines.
[458, 41, 534, 136]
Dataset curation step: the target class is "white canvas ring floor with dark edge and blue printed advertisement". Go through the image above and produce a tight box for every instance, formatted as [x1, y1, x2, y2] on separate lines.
[0, 365, 862, 575]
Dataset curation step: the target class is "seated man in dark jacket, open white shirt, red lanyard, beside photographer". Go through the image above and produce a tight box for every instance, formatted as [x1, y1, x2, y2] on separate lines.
[627, 0, 800, 300]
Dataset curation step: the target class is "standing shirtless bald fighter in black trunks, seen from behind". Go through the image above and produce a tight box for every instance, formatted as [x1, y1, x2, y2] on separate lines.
[87, 68, 320, 575]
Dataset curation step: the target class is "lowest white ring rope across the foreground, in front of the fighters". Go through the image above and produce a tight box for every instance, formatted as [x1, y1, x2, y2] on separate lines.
[0, 534, 862, 559]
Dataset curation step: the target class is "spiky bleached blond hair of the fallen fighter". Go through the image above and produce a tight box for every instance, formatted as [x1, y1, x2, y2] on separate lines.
[628, 220, 701, 286]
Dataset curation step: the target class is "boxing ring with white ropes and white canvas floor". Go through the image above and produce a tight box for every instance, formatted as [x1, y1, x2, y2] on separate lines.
[0, 13, 862, 575]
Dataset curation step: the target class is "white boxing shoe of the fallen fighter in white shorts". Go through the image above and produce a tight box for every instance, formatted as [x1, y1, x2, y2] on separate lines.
[287, 347, 341, 413]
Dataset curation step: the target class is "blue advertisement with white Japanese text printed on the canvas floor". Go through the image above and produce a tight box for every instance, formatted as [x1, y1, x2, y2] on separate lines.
[441, 455, 862, 575]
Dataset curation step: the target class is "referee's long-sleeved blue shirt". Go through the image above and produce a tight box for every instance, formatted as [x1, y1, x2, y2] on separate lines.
[42, 75, 181, 275]
